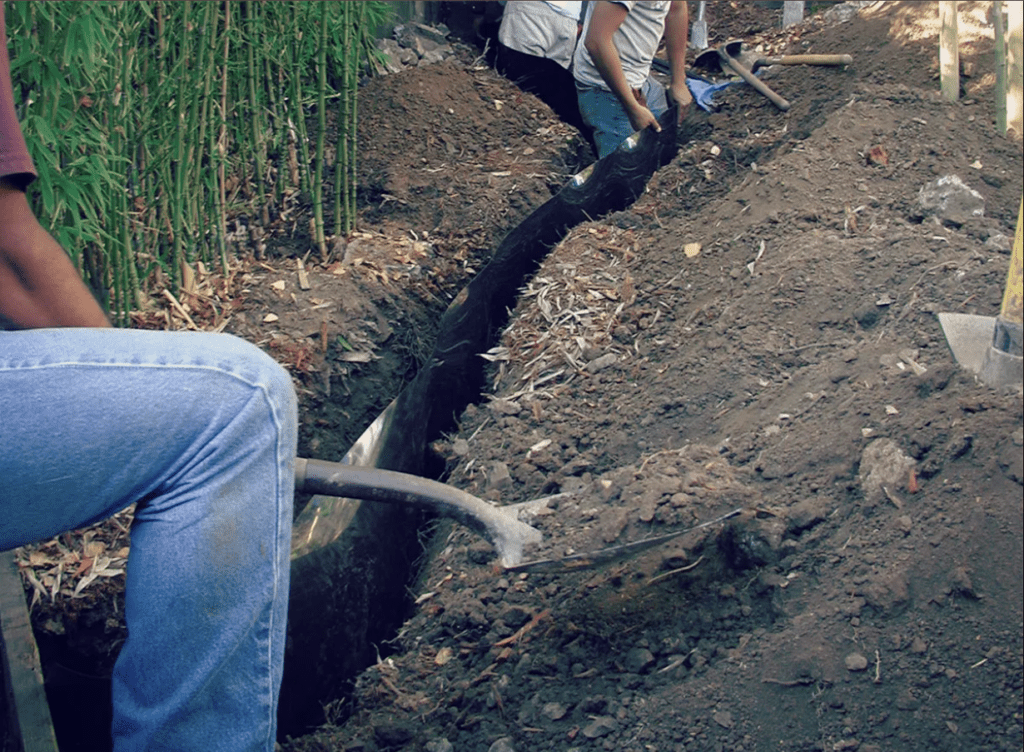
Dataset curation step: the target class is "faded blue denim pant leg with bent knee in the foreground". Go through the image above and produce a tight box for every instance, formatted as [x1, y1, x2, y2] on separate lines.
[0, 329, 297, 752]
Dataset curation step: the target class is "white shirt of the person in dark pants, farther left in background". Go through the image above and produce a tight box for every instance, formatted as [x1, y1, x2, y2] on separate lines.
[498, 0, 583, 70]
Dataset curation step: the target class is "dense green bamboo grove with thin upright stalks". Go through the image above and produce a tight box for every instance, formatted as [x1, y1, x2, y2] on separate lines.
[6, 0, 390, 323]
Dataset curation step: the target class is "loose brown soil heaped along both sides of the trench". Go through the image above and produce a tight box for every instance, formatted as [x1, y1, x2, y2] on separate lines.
[4, 2, 1024, 752]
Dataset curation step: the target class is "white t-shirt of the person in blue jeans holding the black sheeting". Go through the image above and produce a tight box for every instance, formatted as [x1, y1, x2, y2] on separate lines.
[577, 0, 672, 89]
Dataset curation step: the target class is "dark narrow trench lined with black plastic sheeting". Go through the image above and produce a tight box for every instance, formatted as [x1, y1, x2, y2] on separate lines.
[281, 1, 888, 736]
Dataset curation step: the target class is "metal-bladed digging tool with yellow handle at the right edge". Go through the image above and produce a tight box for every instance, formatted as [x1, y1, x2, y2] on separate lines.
[938, 199, 1024, 389]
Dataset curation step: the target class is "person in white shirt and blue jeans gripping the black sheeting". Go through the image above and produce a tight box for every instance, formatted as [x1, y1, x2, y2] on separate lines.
[573, 0, 693, 158]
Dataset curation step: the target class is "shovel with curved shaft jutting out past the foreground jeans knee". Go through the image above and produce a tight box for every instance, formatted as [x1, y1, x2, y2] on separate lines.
[295, 457, 740, 572]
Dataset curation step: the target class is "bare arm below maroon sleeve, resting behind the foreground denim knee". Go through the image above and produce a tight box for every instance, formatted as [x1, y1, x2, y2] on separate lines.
[0, 178, 110, 329]
